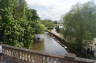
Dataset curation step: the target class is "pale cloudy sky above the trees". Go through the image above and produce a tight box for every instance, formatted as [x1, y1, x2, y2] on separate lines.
[26, 0, 96, 20]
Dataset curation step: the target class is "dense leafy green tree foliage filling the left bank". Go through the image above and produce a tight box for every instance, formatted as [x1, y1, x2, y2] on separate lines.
[0, 0, 42, 48]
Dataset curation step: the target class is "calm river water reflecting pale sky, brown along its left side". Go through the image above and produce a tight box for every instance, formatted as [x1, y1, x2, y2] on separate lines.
[32, 34, 67, 55]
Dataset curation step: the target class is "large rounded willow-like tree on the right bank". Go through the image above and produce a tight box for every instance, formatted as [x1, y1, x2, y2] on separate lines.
[63, 2, 96, 56]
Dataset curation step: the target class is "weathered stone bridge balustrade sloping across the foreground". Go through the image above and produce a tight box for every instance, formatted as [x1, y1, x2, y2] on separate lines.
[1, 44, 96, 63]
